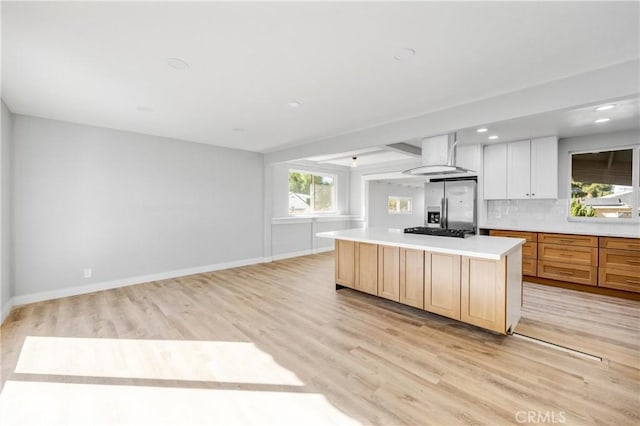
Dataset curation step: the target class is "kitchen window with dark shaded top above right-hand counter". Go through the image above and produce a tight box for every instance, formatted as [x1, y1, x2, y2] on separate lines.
[570, 148, 640, 219]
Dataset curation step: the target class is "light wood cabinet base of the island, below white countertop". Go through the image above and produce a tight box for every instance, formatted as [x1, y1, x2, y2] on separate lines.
[335, 240, 522, 334]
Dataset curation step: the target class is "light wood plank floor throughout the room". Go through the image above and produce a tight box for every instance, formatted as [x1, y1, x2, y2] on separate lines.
[0, 253, 640, 425]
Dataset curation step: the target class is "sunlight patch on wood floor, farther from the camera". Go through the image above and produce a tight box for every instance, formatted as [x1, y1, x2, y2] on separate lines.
[15, 336, 304, 386]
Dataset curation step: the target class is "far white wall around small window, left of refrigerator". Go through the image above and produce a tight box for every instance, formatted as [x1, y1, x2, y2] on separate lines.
[369, 181, 424, 229]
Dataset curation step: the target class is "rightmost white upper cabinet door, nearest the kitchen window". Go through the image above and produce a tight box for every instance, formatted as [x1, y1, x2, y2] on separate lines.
[531, 136, 558, 199]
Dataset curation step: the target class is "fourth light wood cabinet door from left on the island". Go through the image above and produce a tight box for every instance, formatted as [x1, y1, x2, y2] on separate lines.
[400, 248, 424, 309]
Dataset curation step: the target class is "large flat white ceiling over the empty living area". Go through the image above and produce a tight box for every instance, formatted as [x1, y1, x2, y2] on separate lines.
[2, 1, 640, 152]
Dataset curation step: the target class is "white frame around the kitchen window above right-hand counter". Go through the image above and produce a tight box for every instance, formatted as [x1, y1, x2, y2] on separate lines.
[566, 144, 640, 225]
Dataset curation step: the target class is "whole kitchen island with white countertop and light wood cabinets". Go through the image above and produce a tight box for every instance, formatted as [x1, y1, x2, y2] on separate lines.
[316, 228, 525, 334]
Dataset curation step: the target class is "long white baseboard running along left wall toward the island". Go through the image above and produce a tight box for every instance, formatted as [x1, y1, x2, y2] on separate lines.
[2, 246, 333, 322]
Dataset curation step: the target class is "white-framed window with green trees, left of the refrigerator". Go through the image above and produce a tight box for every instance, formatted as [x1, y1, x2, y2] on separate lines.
[289, 170, 336, 214]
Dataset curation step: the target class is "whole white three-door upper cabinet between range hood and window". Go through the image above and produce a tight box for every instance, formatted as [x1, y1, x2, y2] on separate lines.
[483, 136, 558, 200]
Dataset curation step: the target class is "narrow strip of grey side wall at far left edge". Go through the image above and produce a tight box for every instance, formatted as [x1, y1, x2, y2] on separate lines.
[0, 102, 13, 320]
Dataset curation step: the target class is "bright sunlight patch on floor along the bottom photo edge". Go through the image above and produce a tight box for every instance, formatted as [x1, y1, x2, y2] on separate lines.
[0, 380, 358, 426]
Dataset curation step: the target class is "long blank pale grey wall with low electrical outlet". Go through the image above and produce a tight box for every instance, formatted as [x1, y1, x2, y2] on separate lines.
[14, 115, 264, 296]
